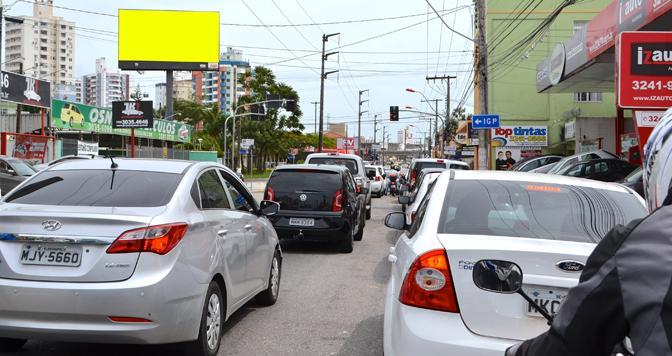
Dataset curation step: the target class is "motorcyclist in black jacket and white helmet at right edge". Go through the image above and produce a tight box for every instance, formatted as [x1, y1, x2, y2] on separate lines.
[506, 109, 672, 356]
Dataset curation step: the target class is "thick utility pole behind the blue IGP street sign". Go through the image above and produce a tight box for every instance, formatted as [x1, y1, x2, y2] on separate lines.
[474, 0, 490, 170]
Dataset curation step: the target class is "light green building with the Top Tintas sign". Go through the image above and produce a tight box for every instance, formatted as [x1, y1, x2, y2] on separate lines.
[486, 0, 618, 164]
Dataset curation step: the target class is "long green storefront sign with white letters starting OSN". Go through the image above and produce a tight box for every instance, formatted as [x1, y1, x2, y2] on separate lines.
[51, 99, 192, 142]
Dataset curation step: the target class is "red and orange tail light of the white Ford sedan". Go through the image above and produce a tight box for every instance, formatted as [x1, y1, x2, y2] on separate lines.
[399, 250, 460, 313]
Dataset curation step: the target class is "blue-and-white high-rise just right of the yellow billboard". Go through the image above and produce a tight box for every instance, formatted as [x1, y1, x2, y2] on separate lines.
[193, 47, 253, 113]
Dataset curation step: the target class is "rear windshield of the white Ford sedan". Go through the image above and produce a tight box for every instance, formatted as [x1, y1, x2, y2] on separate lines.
[438, 180, 647, 243]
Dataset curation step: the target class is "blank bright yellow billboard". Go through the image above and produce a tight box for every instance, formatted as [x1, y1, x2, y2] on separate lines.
[119, 10, 219, 70]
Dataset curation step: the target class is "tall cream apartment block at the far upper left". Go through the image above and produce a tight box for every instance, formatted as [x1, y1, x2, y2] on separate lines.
[3, 0, 75, 84]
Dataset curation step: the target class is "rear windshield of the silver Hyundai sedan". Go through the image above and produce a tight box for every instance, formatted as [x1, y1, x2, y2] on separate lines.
[4, 169, 182, 207]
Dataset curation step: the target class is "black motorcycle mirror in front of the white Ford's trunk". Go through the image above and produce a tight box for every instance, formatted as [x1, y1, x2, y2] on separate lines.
[473, 260, 523, 294]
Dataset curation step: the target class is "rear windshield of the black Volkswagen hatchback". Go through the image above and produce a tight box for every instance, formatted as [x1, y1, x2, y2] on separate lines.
[268, 169, 342, 193]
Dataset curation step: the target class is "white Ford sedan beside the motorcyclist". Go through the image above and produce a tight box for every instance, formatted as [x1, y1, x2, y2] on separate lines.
[383, 171, 647, 356]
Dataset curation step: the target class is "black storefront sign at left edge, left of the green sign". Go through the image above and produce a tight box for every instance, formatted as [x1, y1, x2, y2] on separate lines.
[0, 71, 51, 109]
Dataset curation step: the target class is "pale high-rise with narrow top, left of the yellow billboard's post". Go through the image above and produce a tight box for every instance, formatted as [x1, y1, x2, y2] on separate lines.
[82, 58, 130, 108]
